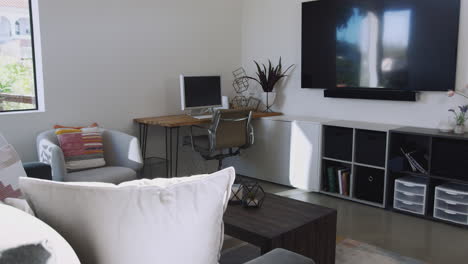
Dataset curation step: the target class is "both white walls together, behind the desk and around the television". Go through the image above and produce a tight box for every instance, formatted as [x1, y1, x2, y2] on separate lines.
[4, 0, 468, 169]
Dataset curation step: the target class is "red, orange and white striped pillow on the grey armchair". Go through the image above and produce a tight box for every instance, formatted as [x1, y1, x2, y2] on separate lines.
[55, 127, 106, 171]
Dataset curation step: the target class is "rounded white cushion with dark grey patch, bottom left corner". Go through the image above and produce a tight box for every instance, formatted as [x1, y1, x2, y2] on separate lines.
[0, 203, 80, 264]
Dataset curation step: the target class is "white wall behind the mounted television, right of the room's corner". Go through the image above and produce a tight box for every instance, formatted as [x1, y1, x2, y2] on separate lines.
[242, 0, 468, 127]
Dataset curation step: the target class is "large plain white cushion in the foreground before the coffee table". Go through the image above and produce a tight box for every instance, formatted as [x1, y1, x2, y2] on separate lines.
[20, 168, 235, 264]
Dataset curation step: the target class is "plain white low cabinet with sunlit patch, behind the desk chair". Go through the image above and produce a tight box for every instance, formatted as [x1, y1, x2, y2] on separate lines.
[225, 116, 330, 192]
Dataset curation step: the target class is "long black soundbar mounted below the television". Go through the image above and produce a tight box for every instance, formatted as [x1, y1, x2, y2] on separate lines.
[324, 88, 418, 102]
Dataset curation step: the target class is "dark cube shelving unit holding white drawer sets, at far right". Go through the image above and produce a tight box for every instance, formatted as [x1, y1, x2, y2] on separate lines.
[387, 127, 468, 227]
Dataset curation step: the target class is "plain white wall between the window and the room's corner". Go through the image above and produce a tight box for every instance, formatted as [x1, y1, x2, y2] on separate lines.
[0, 0, 241, 165]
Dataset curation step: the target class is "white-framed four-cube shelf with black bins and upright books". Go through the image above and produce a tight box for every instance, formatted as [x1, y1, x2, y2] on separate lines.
[321, 121, 399, 208]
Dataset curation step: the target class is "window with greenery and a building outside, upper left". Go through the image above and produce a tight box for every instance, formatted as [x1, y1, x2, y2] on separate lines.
[0, 0, 42, 113]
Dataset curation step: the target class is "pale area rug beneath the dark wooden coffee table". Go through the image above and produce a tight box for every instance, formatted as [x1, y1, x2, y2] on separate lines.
[220, 239, 424, 264]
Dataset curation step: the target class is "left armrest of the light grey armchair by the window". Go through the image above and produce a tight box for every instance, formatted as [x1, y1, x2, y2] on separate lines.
[37, 138, 67, 181]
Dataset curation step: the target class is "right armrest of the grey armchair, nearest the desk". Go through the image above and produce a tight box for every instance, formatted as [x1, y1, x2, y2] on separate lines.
[103, 130, 143, 171]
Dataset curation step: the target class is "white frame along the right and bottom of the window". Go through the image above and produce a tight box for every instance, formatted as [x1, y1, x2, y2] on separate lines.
[0, 0, 45, 116]
